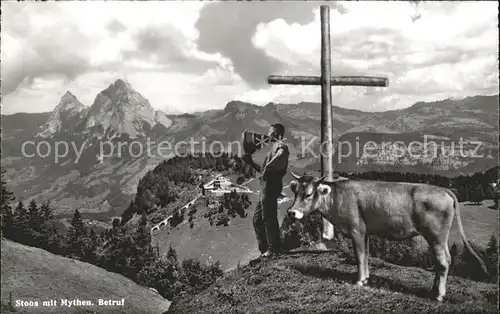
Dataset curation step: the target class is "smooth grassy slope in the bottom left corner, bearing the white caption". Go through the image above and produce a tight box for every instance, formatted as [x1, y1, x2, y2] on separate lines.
[1, 239, 170, 314]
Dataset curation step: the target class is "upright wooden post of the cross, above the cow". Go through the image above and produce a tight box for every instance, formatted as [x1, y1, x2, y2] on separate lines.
[320, 5, 333, 181]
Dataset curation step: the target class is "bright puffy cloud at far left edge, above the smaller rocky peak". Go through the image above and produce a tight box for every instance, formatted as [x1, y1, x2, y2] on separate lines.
[1, 6, 92, 94]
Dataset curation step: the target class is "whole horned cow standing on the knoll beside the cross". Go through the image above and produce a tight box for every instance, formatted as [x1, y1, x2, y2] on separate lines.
[287, 172, 487, 301]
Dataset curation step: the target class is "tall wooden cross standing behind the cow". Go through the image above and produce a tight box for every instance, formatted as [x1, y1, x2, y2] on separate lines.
[268, 5, 389, 236]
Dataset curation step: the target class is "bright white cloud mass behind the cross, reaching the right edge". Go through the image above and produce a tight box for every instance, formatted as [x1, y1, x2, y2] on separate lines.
[247, 2, 498, 111]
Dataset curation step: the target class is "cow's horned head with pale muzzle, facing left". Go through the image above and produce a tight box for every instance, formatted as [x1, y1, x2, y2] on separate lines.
[287, 172, 331, 219]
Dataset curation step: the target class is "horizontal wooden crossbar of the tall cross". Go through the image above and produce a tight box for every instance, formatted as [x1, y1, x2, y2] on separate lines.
[267, 75, 389, 87]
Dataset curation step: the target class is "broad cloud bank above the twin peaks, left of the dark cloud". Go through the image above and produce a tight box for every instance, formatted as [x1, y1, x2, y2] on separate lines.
[1, 3, 217, 95]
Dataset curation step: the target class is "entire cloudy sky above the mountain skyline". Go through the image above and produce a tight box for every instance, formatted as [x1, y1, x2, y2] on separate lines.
[1, 1, 499, 114]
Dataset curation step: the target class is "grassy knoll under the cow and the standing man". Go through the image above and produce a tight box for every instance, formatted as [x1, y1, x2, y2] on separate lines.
[169, 249, 498, 313]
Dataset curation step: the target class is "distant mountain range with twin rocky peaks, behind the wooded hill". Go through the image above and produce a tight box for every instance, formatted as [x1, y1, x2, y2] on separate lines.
[2, 79, 498, 213]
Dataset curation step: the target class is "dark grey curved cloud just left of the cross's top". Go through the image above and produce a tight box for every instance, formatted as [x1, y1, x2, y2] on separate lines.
[196, 1, 346, 88]
